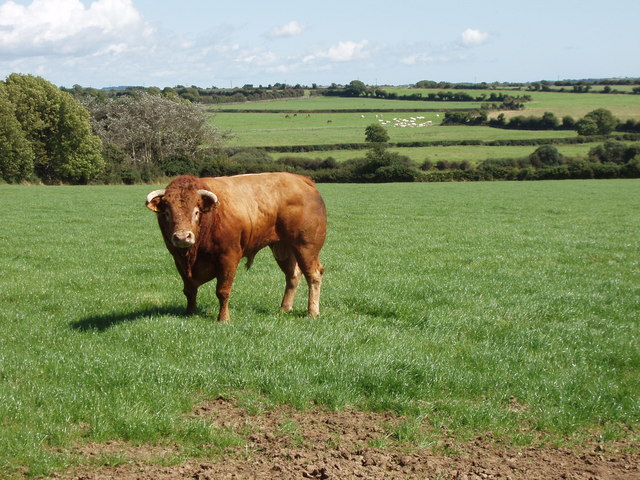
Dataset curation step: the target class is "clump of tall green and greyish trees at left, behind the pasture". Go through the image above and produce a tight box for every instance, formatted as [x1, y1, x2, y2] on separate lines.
[0, 74, 228, 184]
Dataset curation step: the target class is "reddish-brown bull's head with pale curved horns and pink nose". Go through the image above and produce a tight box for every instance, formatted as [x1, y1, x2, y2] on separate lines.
[146, 184, 218, 248]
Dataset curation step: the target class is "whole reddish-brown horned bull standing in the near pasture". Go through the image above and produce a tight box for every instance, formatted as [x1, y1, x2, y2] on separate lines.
[146, 173, 327, 322]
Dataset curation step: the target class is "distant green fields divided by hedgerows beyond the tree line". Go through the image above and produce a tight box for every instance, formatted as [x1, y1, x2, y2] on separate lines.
[207, 88, 640, 154]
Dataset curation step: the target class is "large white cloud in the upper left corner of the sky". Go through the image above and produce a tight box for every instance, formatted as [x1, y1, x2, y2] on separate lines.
[0, 0, 153, 58]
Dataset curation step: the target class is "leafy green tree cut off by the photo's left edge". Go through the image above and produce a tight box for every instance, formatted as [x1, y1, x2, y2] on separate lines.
[0, 82, 34, 183]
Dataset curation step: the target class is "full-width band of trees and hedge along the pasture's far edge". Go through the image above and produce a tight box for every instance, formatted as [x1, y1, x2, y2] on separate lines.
[0, 74, 640, 184]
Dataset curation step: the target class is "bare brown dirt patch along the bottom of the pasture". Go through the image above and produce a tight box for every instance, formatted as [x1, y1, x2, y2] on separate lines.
[52, 399, 640, 480]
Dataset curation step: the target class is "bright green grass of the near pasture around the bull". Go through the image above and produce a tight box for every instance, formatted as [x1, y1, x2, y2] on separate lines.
[0, 180, 640, 478]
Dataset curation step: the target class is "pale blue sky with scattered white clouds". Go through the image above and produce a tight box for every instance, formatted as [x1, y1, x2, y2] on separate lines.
[0, 0, 640, 88]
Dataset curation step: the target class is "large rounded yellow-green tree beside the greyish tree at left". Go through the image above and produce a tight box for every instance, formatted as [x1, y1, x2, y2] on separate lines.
[5, 73, 104, 183]
